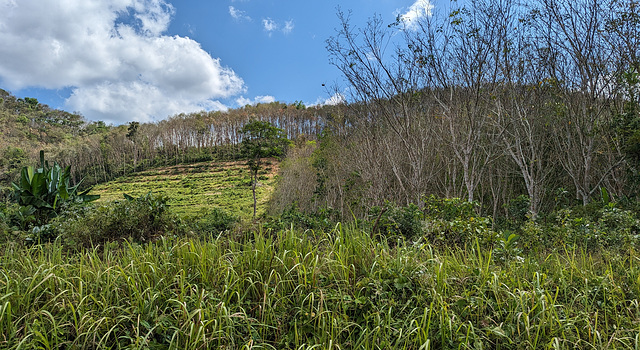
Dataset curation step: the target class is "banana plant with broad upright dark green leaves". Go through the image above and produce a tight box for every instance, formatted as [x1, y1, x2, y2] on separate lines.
[12, 151, 100, 218]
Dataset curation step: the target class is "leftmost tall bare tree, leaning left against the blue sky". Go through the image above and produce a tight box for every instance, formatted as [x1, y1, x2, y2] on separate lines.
[327, 12, 437, 204]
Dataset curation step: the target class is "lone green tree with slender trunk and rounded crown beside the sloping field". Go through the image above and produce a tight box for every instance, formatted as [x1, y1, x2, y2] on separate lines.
[240, 120, 290, 219]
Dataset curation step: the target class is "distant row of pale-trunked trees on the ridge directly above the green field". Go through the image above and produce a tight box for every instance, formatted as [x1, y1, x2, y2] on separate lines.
[56, 102, 325, 183]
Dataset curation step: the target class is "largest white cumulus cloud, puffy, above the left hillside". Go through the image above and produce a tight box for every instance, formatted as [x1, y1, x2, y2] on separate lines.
[0, 0, 245, 124]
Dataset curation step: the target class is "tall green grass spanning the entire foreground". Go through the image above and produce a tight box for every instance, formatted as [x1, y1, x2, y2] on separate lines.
[0, 228, 640, 349]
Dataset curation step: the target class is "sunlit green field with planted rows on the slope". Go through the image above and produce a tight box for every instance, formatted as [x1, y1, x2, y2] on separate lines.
[91, 160, 278, 218]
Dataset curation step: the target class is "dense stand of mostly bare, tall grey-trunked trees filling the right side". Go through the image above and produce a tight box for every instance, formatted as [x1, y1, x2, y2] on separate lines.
[274, 0, 640, 221]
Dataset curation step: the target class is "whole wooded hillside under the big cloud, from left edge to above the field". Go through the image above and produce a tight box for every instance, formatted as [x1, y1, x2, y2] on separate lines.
[0, 89, 324, 198]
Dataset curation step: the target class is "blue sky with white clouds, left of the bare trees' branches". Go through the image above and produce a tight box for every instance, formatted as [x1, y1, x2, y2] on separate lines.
[0, 0, 436, 125]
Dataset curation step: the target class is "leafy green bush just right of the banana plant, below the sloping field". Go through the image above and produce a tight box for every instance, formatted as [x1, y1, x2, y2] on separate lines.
[53, 193, 187, 247]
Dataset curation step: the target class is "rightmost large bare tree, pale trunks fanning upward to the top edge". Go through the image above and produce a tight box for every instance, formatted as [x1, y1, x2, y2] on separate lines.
[537, 0, 621, 204]
